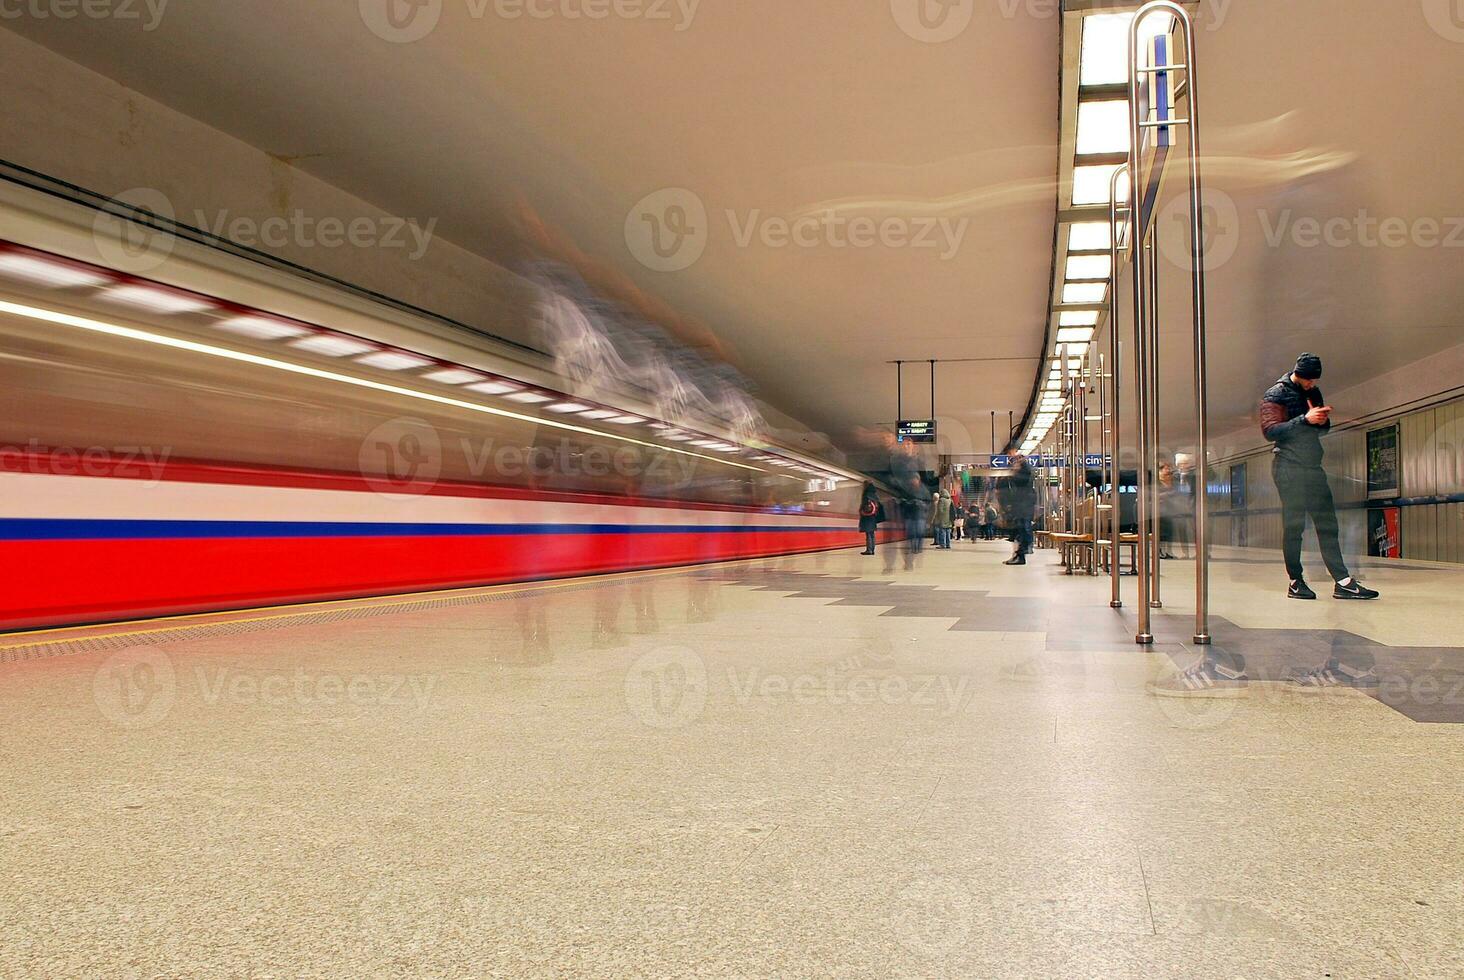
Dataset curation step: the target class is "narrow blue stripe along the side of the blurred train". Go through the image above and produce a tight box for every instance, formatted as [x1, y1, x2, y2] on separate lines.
[0, 517, 854, 541]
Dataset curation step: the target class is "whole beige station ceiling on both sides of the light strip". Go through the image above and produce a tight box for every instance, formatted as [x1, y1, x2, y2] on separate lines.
[6, 0, 1464, 451]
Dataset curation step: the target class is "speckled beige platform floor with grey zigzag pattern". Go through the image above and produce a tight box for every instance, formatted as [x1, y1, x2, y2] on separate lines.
[0, 542, 1464, 979]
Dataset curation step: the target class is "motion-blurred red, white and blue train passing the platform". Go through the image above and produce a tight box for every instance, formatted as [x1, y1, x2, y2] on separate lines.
[0, 185, 890, 630]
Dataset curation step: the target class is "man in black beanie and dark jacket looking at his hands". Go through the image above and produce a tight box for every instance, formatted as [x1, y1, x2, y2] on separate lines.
[1261, 353, 1378, 612]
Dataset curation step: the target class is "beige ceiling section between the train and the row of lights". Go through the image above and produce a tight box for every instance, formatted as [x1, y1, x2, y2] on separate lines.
[0, 0, 1058, 451]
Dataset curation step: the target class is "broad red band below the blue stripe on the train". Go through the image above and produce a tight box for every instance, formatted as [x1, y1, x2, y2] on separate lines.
[0, 529, 895, 630]
